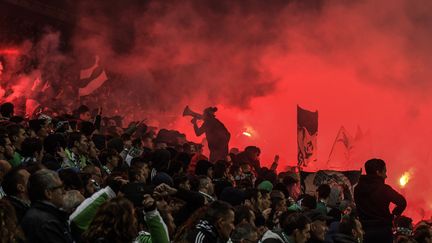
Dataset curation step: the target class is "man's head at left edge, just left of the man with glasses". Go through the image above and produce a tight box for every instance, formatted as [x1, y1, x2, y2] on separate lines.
[2, 167, 30, 199]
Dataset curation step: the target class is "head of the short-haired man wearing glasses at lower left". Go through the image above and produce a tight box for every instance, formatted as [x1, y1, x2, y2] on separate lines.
[28, 169, 64, 208]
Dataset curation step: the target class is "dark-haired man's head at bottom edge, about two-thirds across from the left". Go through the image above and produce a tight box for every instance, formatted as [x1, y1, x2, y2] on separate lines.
[279, 212, 311, 243]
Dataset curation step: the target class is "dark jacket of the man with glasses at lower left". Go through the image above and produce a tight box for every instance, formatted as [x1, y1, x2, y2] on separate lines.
[21, 202, 73, 243]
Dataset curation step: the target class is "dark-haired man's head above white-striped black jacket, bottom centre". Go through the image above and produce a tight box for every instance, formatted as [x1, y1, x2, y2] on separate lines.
[205, 201, 234, 242]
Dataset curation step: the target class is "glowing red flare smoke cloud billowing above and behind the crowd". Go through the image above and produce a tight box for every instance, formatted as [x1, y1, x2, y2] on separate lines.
[72, 0, 432, 220]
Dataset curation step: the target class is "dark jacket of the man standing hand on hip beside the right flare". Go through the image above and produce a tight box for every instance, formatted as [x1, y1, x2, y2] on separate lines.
[354, 175, 406, 228]
